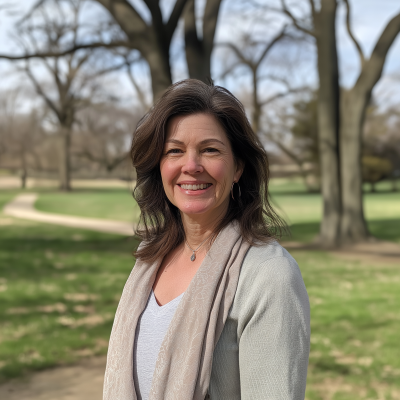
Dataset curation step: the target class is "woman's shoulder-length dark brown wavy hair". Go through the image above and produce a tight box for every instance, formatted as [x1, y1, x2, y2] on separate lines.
[131, 79, 286, 262]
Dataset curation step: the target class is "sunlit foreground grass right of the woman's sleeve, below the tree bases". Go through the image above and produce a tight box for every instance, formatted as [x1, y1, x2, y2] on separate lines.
[292, 251, 400, 400]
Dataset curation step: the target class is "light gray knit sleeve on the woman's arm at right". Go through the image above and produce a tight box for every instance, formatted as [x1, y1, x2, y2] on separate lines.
[238, 254, 310, 400]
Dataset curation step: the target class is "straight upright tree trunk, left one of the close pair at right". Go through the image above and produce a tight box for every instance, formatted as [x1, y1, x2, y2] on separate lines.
[315, 0, 341, 247]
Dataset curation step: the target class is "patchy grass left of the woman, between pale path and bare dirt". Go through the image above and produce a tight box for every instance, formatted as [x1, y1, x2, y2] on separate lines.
[0, 222, 137, 381]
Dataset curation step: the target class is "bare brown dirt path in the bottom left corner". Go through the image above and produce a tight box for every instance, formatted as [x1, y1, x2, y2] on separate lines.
[0, 357, 106, 400]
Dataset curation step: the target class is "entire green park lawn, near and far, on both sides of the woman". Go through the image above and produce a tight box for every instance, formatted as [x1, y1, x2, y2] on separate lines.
[0, 182, 400, 400]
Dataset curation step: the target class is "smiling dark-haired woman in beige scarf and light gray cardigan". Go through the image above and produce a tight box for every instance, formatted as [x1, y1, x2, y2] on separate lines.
[104, 79, 310, 400]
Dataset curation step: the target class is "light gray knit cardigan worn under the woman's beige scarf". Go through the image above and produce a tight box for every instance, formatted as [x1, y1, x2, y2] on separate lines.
[209, 242, 310, 400]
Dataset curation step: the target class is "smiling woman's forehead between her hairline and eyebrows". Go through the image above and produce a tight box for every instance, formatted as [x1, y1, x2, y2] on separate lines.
[166, 114, 228, 143]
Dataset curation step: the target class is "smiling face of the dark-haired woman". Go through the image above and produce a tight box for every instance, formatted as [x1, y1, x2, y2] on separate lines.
[160, 114, 243, 222]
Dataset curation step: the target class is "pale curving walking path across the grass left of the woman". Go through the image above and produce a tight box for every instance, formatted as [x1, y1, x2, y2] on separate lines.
[3, 193, 134, 236]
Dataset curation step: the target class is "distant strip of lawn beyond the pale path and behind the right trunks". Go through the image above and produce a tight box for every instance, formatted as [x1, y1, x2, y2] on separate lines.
[35, 179, 400, 243]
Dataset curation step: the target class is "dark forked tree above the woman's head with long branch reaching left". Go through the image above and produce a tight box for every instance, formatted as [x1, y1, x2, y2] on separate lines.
[0, 0, 225, 99]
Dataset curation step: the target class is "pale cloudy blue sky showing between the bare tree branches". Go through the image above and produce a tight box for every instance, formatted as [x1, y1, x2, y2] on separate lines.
[0, 0, 400, 110]
